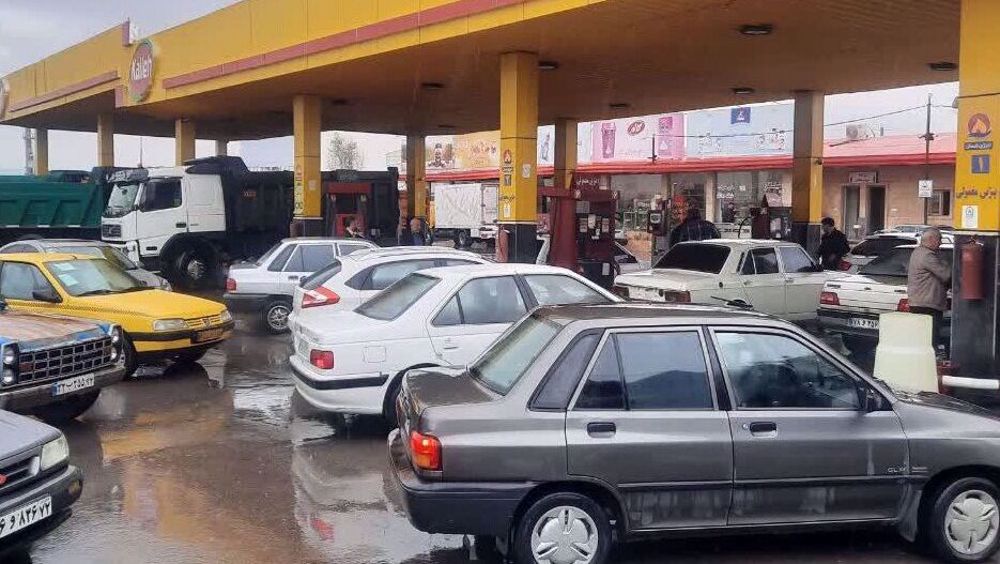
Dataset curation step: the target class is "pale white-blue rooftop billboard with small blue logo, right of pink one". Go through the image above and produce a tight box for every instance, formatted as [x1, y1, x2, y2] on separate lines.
[686, 103, 794, 158]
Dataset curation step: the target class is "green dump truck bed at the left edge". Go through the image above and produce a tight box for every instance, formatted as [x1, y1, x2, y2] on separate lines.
[0, 168, 111, 245]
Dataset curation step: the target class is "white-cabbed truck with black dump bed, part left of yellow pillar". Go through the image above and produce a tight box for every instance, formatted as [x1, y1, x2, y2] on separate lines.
[101, 157, 292, 288]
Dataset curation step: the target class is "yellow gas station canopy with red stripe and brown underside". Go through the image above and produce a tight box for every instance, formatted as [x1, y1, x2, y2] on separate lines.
[0, 0, 960, 140]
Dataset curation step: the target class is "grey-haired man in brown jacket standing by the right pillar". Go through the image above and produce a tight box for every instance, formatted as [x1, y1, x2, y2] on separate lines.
[906, 227, 951, 352]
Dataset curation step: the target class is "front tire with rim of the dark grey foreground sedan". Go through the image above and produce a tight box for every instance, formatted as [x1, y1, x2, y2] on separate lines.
[921, 478, 1000, 564]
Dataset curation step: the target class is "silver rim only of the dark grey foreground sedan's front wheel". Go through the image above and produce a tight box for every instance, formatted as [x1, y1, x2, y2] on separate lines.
[944, 490, 1000, 556]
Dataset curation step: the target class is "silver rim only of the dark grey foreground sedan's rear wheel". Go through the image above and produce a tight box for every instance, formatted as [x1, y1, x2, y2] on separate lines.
[531, 505, 600, 564]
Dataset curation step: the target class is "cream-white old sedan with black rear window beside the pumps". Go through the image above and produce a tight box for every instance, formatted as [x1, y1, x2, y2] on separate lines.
[615, 239, 843, 320]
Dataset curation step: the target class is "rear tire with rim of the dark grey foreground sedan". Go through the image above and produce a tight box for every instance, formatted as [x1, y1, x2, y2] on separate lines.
[513, 492, 613, 564]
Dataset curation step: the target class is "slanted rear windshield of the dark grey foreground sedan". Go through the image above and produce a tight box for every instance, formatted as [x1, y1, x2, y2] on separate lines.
[469, 315, 562, 395]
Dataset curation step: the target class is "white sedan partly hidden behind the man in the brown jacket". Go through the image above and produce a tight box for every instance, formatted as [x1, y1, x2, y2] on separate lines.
[817, 244, 954, 352]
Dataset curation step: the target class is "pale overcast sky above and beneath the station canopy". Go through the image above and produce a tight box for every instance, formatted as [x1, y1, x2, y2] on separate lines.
[0, 0, 958, 173]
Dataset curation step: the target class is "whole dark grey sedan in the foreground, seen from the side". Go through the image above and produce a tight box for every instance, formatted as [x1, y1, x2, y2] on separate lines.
[389, 304, 1000, 564]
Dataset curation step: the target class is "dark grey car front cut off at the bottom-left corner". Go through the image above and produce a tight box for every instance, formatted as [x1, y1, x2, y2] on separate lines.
[0, 411, 83, 562]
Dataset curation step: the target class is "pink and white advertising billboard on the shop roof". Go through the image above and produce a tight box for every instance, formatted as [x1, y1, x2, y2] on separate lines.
[589, 113, 684, 163]
